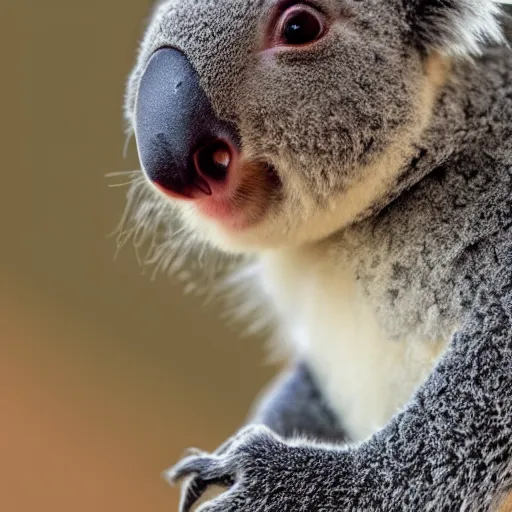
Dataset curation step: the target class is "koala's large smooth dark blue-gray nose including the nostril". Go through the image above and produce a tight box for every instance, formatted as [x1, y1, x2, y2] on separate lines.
[135, 48, 239, 198]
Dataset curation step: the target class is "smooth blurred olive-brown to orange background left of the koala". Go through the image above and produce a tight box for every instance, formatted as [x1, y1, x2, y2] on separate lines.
[0, 0, 272, 512]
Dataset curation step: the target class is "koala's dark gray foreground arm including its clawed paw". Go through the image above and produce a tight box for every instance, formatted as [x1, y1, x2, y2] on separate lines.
[170, 286, 512, 512]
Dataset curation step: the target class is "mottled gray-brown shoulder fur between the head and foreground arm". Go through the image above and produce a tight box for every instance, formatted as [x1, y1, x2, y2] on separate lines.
[340, 48, 512, 339]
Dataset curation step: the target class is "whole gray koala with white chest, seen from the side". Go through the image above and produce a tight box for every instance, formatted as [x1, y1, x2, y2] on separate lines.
[125, 0, 512, 512]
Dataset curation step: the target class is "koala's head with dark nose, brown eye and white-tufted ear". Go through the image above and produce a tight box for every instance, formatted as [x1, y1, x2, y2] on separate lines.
[126, 0, 500, 251]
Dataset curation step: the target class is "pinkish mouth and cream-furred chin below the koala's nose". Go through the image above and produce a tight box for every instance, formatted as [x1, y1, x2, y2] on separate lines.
[171, 158, 364, 254]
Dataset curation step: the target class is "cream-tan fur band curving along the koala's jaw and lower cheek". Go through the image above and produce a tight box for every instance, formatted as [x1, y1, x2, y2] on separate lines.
[185, 54, 450, 252]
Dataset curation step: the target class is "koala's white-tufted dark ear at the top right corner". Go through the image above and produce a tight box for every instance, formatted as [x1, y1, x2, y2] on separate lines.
[406, 0, 504, 55]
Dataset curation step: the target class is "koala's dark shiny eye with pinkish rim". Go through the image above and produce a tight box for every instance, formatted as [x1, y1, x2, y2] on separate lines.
[277, 5, 324, 45]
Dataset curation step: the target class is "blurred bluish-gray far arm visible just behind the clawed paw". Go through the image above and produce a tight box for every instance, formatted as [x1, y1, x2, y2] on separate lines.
[249, 362, 345, 442]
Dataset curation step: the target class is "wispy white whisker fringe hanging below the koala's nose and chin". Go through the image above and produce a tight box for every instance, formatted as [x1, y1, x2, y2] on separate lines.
[108, 170, 271, 344]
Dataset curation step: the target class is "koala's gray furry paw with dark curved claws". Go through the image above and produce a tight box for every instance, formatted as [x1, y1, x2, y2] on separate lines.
[167, 426, 307, 512]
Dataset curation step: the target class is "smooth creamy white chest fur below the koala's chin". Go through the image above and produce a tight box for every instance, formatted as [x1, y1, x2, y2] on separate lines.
[261, 248, 446, 441]
